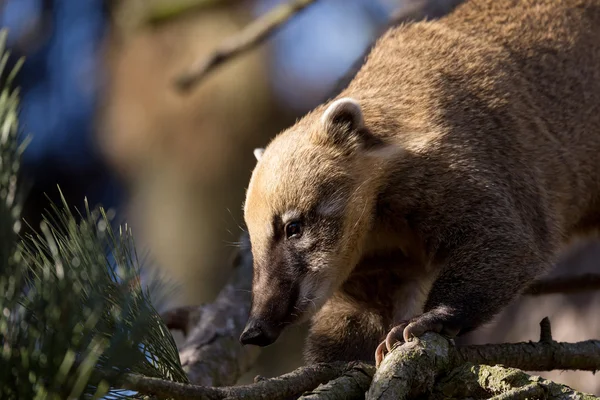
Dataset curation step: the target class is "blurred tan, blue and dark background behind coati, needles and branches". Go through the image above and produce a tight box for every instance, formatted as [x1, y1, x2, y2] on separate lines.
[0, 0, 600, 394]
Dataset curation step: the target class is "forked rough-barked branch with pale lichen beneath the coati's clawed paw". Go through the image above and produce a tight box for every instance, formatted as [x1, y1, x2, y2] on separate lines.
[367, 318, 600, 399]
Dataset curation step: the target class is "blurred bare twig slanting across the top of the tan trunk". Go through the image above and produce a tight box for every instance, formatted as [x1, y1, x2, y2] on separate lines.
[175, 0, 316, 92]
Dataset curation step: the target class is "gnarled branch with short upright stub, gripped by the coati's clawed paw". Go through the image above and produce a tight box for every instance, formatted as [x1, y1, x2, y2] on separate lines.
[367, 318, 600, 400]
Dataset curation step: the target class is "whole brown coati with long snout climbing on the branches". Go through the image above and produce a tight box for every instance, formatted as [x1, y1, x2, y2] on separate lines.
[240, 0, 600, 363]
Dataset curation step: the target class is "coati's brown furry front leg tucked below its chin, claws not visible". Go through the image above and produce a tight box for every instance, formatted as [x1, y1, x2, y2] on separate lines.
[304, 294, 389, 364]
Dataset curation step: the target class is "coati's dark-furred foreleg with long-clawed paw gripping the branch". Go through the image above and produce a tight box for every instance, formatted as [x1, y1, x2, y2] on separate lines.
[386, 225, 553, 362]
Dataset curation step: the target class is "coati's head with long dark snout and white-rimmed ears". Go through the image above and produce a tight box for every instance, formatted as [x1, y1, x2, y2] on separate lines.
[240, 98, 392, 346]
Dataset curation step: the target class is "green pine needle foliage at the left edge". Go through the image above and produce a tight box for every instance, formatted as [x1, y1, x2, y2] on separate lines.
[0, 32, 188, 399]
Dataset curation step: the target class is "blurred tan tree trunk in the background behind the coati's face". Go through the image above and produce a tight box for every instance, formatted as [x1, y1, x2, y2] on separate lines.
[99, 1, 288, 304]
